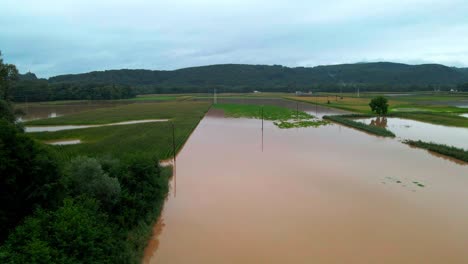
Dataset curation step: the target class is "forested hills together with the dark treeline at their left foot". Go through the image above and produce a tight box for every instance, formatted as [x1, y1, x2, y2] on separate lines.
[13, 62, 468, 102]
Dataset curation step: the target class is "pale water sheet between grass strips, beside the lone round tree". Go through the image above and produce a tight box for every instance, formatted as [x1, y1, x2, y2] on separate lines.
[357, 117, 468, 149]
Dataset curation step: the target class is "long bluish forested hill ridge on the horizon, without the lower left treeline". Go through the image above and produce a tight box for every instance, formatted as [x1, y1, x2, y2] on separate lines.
[49, 62, 468, 91]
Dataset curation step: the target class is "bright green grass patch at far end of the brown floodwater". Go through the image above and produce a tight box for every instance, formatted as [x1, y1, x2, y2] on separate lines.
[214, 104, 328, 129]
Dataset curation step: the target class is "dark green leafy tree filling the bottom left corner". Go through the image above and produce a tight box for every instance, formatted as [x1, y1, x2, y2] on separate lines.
[0, 198, 125, 263]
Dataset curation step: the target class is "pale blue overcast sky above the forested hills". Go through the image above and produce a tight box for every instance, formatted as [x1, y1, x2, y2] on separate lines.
[0, 0, 468, 77]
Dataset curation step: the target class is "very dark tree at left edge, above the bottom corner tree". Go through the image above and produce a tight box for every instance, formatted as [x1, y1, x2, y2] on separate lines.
[0, 119, 61, 241]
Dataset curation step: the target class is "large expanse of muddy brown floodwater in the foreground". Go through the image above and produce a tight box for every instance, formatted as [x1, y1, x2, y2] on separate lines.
[143, 104, 468, 264]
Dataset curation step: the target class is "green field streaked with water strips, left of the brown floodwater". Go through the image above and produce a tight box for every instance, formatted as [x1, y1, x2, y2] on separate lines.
[26, 102, 210, 159]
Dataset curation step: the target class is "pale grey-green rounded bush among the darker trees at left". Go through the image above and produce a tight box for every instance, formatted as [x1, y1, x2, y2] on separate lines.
[63, 157, 121, 210]
